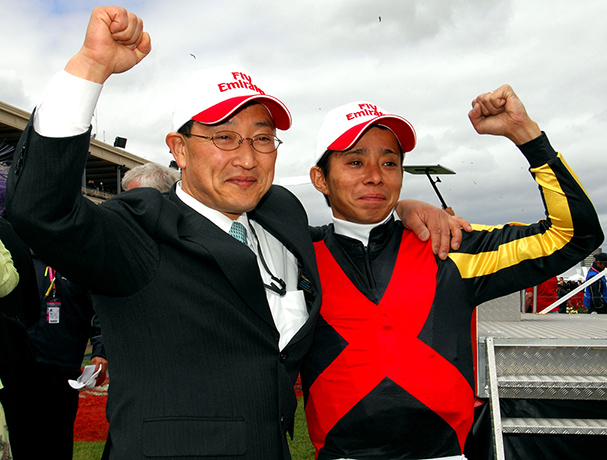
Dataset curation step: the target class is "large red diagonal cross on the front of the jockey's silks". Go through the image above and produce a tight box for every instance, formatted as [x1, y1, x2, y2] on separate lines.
[306, 235, 474, 452]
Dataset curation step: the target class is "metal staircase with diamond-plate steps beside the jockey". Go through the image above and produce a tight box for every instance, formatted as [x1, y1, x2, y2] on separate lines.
[486, 334, 607, 460]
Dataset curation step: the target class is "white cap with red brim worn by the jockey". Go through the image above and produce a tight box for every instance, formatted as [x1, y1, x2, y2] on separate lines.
[314, 101, 417, 161]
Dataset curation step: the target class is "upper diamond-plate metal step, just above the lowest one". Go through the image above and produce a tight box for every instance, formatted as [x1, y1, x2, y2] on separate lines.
[497, 375, 607, 400]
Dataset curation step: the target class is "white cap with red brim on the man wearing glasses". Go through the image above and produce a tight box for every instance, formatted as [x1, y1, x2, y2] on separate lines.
[173, 65, 291, 131]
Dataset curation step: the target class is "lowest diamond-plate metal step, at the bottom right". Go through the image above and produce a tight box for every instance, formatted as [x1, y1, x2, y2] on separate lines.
[502, 418, 607, 435]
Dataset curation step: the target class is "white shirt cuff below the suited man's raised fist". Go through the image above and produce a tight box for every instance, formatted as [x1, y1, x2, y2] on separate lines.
[34, 70, 103, 137]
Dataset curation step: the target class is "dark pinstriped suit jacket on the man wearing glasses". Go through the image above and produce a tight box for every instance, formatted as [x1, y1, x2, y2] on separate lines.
[7, 122, 320, 460]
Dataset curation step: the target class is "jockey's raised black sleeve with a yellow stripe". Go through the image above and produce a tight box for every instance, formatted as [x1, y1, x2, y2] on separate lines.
[449, 134, 603, 305]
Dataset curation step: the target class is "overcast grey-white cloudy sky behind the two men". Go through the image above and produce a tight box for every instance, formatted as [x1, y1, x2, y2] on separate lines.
[0, 0, 607, 256]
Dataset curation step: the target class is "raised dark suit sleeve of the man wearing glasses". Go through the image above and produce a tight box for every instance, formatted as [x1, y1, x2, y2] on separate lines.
[6, 119, 168, 295]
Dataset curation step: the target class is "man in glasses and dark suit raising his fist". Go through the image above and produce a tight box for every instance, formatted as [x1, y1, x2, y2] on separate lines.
[8, 7, 464, 460]
